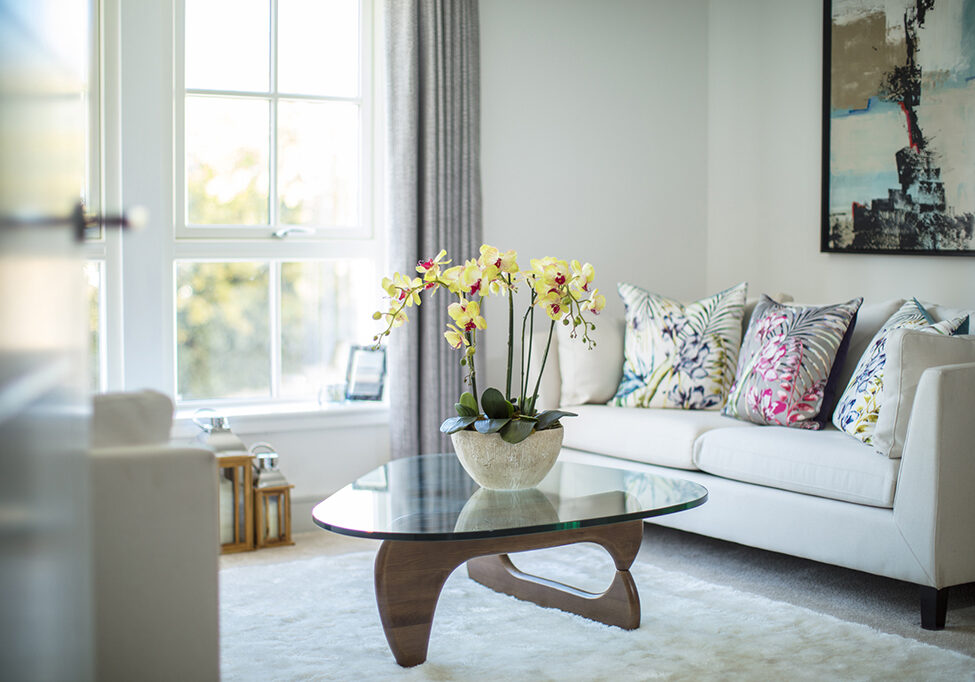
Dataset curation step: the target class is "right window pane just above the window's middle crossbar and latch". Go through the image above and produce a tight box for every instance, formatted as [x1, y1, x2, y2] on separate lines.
[278, 100, 359, 227]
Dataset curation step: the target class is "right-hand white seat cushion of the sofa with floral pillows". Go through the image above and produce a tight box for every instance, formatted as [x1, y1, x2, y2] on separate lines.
[694, 426, 898, 508]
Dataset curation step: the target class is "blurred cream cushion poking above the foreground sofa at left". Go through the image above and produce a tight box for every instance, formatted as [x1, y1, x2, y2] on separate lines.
[90, 390, 173, 448]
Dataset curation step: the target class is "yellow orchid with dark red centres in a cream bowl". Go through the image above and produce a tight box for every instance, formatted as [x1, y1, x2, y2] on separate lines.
[373, 244, 606, 490]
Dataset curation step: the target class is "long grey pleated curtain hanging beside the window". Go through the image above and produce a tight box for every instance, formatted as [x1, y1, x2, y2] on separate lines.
[385, 0, 482, 457]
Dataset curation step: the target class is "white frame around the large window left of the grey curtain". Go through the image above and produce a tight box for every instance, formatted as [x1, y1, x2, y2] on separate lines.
[114, 0, 386, 414]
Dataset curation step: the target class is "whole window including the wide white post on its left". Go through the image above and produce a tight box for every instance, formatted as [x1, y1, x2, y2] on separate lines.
[106, 0, 385, 409]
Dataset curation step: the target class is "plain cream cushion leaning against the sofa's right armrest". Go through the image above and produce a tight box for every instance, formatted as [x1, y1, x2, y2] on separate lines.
[873, 329, 975, 458]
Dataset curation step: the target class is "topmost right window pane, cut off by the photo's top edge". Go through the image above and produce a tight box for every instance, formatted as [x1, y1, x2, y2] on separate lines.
[278, 0, 359, 97]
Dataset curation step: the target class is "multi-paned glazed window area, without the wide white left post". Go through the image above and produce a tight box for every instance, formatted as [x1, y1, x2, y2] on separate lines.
[174, 0, 378, 402]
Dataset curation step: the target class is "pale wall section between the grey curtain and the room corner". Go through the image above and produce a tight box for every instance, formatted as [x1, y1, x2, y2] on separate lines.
[479, 0, 707, 385]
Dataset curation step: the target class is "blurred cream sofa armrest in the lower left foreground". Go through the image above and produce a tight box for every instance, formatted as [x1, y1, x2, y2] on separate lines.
[90, 445, 220, 680]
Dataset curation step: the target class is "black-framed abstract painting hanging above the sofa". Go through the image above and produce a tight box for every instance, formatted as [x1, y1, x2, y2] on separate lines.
[820, 0, 975, 256]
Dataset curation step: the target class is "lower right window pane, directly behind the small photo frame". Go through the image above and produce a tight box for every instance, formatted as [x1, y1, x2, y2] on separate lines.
[281, 259, 378, 396]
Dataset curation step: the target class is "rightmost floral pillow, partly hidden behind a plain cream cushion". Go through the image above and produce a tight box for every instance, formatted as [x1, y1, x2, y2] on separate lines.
[833, 298, 968, 445]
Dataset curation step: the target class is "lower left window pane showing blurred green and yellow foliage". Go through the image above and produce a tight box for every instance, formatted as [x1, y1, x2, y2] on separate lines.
[176, 262, 271, 400]
